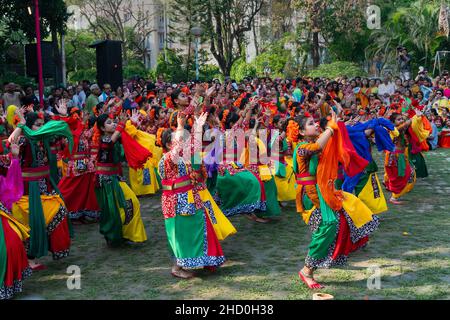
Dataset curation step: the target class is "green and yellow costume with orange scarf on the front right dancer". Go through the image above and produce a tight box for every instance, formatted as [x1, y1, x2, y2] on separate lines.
[294, 121, 379, 270]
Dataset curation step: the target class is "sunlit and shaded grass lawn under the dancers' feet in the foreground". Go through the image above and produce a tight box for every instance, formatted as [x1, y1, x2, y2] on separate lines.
[17, 149, 450, 300]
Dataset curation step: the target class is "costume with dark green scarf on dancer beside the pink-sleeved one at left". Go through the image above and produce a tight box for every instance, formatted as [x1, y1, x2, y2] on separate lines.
[12, 121, 73, 260]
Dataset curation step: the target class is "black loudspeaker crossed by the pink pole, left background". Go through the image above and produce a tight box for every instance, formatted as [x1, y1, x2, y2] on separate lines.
[25, 41, 57, 78]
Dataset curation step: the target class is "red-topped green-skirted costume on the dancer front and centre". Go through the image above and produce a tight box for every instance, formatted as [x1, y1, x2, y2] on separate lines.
[158, 131, 236, 269]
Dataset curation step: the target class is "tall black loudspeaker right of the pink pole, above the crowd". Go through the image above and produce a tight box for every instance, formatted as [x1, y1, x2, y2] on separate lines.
[89, 40, 123, 90]
